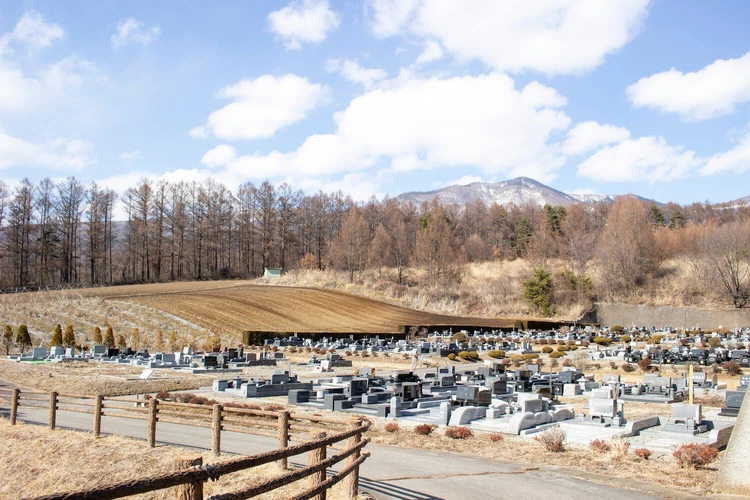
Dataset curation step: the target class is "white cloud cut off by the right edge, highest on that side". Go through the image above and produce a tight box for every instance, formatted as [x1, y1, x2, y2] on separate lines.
[625, 52, 750, 121]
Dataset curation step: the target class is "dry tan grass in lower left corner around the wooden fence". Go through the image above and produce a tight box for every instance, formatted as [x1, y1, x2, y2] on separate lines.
[0, 419, 368, 500]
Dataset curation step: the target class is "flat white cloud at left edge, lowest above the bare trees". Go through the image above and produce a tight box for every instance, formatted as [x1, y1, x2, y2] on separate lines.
[0, 134, 94, 171]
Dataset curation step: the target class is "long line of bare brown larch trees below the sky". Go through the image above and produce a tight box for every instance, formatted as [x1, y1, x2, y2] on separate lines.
[0, 177, 750, 308]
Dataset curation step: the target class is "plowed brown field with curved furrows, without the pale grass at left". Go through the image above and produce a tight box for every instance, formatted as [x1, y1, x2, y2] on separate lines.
[64, 281, 513, 334]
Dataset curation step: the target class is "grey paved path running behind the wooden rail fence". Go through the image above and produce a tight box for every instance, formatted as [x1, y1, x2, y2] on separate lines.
[0, 382, 694, 500]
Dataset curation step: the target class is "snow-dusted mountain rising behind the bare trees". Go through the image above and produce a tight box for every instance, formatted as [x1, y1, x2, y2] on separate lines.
[396, 177, 615, 207]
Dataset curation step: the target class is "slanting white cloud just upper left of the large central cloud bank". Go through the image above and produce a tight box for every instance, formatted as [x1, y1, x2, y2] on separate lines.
[190, 74, 328, 140]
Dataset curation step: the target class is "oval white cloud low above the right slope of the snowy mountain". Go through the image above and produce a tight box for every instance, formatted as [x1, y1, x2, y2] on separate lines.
[578, 137, 703, 184]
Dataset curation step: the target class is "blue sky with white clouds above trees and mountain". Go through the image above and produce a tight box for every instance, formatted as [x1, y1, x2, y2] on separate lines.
[0, 0, 750, 204]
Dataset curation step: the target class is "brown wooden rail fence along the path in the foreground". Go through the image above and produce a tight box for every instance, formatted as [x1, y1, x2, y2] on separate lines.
[0, 388, 370, 500]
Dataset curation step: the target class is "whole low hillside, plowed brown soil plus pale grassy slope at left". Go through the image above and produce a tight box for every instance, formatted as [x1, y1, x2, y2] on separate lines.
[0, 281, 524, 343]
